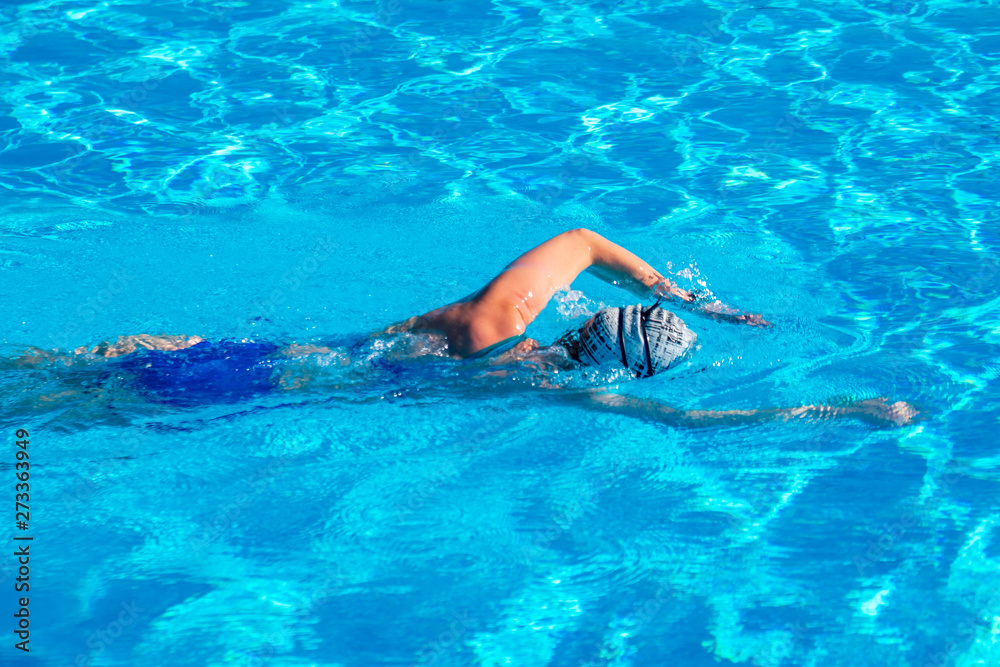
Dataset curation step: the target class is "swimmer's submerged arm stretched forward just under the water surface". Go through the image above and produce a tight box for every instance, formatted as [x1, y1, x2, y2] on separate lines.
[586, 391, 919, 428]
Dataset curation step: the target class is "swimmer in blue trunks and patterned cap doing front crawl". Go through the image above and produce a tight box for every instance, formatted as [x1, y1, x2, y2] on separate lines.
[12, 229, 917, 426]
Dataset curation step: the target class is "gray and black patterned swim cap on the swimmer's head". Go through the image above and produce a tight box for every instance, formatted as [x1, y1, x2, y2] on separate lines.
[579, 306, 697, 378]
